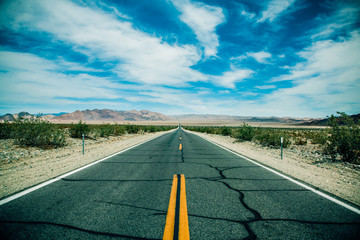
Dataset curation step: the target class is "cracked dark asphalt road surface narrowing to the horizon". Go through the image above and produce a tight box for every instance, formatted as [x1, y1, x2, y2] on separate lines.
[0, 126, 360, 240]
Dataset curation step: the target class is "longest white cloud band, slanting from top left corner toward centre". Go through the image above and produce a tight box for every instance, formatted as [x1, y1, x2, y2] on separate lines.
[0, 0, 207, 86]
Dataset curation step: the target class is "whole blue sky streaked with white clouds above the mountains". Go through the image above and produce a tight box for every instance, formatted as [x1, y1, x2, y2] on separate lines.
[0, 0, 360, 117]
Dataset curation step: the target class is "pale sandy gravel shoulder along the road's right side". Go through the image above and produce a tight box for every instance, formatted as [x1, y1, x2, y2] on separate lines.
[188, 132, 360, 206]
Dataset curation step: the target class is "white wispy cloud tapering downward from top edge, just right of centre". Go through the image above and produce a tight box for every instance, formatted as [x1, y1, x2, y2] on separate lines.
[172, 0, 225, 57]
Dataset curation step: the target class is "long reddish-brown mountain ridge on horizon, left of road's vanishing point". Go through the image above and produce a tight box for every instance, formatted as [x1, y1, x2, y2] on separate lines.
[53, 109, 173, 121]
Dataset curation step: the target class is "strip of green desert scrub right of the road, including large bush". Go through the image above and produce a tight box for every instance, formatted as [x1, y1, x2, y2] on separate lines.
[184, 112, 360, 163]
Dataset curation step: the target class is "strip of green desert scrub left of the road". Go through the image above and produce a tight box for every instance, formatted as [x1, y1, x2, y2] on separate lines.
[0, 118, 176, 148]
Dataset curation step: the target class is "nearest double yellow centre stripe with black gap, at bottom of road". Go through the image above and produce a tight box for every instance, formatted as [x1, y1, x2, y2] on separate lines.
[163, 174, 190, 240]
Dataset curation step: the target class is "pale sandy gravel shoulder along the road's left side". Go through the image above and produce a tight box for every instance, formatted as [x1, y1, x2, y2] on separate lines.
[0, 130, 173, 199]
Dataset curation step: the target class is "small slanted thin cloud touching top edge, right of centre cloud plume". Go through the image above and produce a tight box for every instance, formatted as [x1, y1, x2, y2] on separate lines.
[257, 0, 296, 22]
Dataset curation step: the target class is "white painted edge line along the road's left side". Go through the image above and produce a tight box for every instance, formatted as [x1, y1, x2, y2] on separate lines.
[0, 129, 176, 206]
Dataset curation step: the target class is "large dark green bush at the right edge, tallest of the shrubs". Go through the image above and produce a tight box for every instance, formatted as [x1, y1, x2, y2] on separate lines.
[326, 112, 360, 163]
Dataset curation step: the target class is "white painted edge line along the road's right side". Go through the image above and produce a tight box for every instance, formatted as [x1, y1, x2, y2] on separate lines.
[188, 131, 360, 214]
